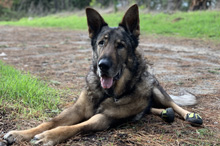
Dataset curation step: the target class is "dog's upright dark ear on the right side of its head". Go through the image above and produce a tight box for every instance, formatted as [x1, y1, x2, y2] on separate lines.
[119, 4, 140, 38]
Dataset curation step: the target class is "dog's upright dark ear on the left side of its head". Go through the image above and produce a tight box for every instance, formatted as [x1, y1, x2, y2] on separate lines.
[86, 8, 108, 38]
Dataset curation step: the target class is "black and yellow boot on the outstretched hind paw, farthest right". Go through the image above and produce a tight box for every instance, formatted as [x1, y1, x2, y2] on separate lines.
[186, 113, 203, 126]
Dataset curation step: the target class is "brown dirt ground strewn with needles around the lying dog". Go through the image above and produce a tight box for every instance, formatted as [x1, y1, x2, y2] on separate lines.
[0, 26, 220, 146]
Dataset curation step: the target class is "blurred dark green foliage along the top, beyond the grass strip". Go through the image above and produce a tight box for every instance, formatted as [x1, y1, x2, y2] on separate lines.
[0, 0, 219, 21]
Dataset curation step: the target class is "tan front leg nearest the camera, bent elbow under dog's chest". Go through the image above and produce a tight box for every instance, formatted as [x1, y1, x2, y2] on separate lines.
[33, 114, 112, 145]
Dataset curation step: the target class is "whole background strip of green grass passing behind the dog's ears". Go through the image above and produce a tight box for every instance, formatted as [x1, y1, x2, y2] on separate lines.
[0, 11, 220, 40]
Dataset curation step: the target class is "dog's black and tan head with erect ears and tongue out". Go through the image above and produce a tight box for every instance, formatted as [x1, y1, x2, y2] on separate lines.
[86, 5, 140, 89]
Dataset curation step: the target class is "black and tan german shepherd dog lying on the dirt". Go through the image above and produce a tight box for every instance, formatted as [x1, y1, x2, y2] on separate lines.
[4, 5, 202, 145]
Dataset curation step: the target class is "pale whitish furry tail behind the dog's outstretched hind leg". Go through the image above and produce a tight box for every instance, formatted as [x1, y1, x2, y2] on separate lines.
[170, 92, 197, 106]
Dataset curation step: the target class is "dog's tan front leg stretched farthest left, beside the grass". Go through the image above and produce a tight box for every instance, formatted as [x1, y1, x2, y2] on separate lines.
[4, 91, 92, 144]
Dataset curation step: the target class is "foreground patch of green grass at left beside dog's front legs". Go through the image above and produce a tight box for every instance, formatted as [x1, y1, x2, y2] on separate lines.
[0, 61, 60, 116]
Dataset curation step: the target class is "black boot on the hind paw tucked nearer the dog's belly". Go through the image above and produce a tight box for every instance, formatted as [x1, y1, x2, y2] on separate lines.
[161, 108, 175, 123]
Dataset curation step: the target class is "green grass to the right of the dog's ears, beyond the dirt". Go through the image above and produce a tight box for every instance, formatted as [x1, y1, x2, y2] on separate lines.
[140, 11, 220, 39]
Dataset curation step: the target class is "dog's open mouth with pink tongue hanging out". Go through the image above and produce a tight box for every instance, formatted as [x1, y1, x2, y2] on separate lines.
[100, 71, 121, 89]
